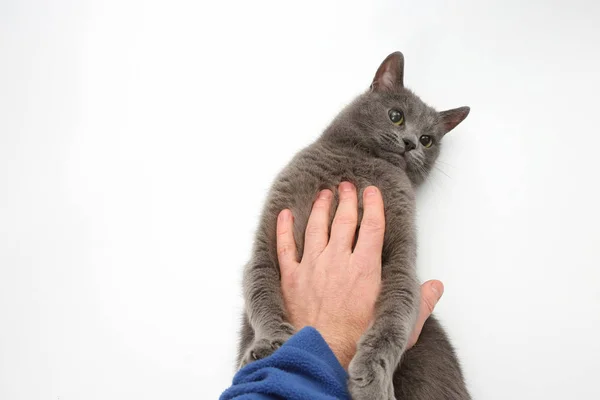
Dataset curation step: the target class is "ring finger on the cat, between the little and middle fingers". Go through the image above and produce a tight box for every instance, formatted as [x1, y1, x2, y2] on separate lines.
[304, 189, 333, 254]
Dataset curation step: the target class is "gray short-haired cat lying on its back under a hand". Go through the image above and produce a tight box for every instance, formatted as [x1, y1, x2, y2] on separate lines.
[238, 52, 470, 400]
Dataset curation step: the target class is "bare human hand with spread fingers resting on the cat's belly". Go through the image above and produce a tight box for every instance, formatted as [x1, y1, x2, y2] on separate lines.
[277, 182, 443, 368]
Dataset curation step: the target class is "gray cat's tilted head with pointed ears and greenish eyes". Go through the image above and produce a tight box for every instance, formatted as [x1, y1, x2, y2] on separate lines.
[328, 52, 469, 184]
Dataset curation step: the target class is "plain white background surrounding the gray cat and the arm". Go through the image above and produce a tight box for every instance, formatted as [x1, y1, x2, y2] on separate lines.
[0, 0, 600, 400]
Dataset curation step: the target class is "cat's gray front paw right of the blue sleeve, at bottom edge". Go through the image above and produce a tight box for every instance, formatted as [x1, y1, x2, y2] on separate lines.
[348, 356, 396, 400]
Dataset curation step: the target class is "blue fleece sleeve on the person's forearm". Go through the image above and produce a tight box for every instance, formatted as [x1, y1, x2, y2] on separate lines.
[220, 327, 350, 400]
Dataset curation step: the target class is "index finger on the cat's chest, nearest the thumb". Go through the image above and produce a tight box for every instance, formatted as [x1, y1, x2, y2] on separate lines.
[354, 186, 385, 255]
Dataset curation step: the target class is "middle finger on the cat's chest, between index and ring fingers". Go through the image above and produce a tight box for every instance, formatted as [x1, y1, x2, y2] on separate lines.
[329, 182, 358, 250]
